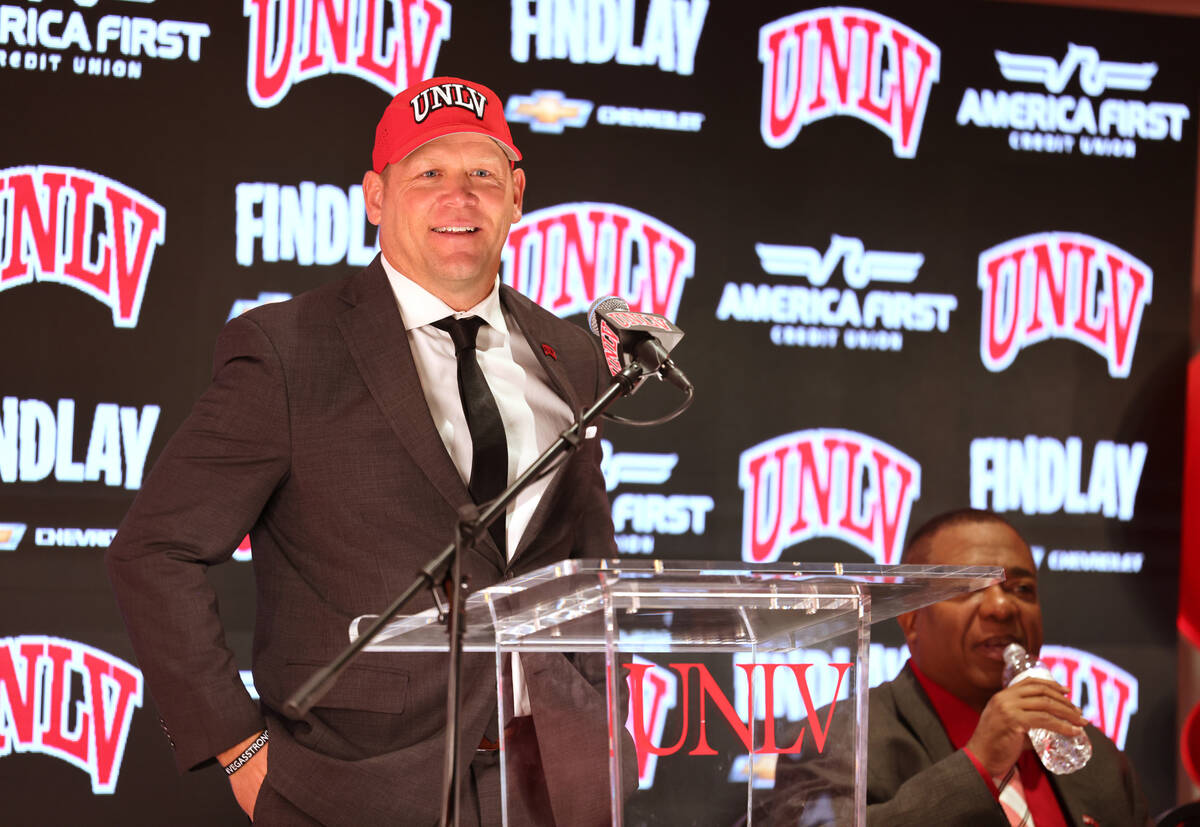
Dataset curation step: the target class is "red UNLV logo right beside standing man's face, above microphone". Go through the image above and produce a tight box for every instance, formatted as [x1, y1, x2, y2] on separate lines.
[502, 202, 696, 322]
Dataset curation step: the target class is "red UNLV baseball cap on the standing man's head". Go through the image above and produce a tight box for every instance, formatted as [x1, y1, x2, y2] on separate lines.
[371, 77, 521, 173]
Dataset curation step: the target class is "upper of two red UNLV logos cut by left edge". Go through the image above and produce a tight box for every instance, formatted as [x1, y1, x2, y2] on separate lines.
[0, 167, 167, 328]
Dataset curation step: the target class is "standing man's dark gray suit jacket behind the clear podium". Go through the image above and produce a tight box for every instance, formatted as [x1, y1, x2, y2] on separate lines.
[107, 258, 616, 825]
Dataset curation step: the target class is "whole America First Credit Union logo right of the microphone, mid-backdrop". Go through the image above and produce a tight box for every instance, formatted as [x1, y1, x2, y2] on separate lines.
[716, 235, 959, 350]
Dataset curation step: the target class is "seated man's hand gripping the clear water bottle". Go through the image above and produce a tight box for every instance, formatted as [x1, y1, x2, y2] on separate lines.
[967, 678, 1087, 778]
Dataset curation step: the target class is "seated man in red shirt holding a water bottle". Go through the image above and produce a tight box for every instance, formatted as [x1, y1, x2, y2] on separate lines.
[769, 510, 1150, 827]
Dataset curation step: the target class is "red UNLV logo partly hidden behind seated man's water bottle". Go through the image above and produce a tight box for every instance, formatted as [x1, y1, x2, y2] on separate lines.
[1039, 646, 1138, 749]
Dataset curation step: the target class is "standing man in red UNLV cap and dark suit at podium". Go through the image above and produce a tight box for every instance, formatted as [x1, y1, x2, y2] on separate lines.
[107, 77, 617, 827]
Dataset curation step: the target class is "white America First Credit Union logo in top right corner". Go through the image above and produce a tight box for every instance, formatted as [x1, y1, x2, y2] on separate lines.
[956, 43, 1190, 158]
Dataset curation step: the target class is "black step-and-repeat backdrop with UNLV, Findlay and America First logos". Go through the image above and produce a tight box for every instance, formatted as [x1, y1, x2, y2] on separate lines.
[0, 0, 1200, 825]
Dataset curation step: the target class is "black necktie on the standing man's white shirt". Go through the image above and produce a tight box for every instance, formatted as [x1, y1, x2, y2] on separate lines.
[433, 316, 509, 555]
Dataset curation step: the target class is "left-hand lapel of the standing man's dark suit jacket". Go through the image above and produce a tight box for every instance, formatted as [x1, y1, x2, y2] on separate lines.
[337, 257, 504, 569]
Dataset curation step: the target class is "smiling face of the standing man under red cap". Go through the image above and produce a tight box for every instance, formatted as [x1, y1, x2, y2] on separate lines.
[362, 132, 524, 310]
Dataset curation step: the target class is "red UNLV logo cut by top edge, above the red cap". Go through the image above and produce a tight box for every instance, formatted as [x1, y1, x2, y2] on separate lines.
[242, 0, 450, 108]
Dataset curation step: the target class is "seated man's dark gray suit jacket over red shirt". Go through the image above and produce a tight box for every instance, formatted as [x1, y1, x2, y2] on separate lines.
[769, 666, 1150, 827]
